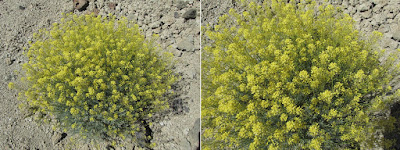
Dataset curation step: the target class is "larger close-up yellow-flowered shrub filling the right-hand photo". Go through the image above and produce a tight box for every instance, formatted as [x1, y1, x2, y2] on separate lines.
[201, 0, 399, 149]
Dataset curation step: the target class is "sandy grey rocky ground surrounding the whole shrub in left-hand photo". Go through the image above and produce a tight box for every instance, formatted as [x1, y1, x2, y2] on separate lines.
[0, 0, 200, 150]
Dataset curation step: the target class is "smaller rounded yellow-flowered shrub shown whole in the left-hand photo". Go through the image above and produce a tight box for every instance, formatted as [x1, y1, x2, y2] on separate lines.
[10, 14, 177, 148]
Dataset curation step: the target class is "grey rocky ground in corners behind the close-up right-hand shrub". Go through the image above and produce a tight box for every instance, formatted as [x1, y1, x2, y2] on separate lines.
[201, 0, 400, 149]
